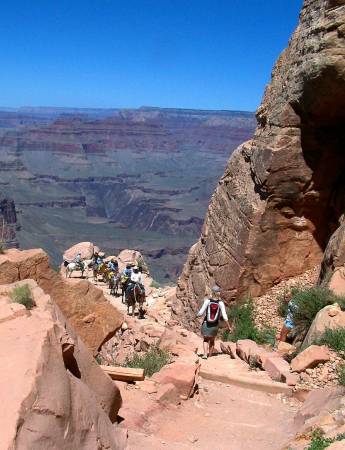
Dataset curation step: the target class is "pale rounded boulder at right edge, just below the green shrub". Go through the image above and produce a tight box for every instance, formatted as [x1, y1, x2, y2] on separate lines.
[303, 303, 345, 348]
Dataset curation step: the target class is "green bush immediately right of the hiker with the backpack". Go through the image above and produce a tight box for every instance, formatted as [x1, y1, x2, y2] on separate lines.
[223, 300, 276, 345]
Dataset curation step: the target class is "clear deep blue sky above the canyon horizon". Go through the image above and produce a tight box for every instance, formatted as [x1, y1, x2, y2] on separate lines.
[0, 0, 302, 110]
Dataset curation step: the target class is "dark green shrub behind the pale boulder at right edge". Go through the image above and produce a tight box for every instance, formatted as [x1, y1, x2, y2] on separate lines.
[292, 286, 343, 333]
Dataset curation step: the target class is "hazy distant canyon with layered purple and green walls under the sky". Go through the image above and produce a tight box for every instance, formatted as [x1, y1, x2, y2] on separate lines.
[0, 108, 255, 281]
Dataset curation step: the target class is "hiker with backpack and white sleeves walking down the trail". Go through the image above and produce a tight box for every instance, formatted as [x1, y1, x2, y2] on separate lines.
[197, 285, 231, 359]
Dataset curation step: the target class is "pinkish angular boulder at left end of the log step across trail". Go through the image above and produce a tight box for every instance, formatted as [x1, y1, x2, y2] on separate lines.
[152, 362, 198, 398]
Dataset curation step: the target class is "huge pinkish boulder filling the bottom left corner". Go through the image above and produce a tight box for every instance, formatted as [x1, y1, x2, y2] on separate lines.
[0, 280, 125, 450]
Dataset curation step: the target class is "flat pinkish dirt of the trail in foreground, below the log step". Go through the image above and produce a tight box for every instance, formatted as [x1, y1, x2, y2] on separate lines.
[124, 380, 297, 450]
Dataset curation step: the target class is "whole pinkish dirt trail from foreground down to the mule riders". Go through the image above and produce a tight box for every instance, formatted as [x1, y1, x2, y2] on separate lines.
[67, 268, 300, 450]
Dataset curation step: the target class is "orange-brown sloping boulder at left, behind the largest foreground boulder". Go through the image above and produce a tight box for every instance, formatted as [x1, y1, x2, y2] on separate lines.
[0, 249, 123, 353]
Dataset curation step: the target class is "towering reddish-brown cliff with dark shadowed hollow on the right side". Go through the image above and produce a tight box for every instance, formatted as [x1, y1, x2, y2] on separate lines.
[175, 0, 345, 323]
